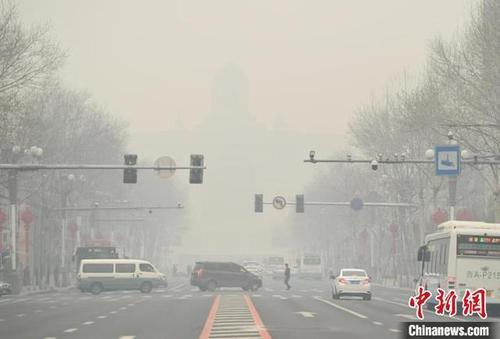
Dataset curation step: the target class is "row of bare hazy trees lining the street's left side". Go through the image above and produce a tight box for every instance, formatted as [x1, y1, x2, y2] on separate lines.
[0, 0, 186, 286]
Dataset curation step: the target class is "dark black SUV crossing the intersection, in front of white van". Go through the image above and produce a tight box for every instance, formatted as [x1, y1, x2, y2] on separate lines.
[191, 261, 262, 291]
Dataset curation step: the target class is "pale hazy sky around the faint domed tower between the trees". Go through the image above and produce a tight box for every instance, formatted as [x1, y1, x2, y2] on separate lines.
[18, 0, 474, 138]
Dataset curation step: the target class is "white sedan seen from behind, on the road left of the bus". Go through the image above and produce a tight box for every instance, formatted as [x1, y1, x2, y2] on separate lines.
[330, 268, 372, 300]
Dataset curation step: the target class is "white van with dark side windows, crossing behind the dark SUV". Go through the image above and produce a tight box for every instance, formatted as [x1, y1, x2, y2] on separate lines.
[77, 259, 167, 294]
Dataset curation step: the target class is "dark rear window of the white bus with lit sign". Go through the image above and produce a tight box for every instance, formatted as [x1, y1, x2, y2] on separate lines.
[457, 234, 500, 257]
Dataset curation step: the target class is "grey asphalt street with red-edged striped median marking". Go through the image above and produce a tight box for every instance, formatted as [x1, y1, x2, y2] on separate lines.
[0, 278, 496, 339]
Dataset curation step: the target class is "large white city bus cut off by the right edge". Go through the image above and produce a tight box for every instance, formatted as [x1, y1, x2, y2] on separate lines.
[417, 221, 500, 306]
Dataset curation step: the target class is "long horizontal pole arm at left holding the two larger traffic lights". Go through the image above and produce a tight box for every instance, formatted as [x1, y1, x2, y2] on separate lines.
[0, 164, 207, 171]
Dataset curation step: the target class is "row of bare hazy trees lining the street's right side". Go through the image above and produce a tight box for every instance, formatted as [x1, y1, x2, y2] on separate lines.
[295, 0, 500, 284]
